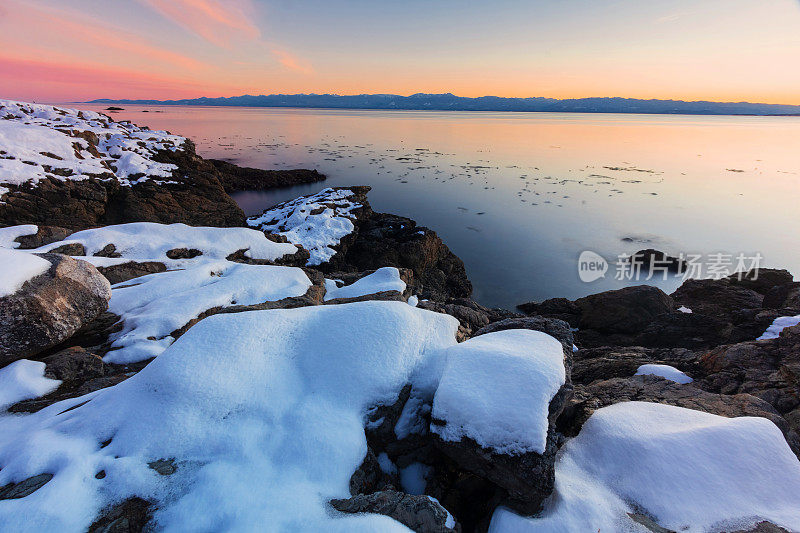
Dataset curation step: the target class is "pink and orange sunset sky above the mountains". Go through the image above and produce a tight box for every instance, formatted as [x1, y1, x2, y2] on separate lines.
[0, 0, 800, 104]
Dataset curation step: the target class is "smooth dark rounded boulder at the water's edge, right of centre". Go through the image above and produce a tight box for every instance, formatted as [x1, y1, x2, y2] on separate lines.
[575, 285, 675, 333]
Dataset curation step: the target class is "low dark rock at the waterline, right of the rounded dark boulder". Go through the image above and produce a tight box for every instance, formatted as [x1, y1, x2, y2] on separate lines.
[671, 278, 764, 317]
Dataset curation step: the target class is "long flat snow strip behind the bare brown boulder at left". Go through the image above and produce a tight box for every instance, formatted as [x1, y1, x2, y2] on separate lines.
[31, 222, 297, 268]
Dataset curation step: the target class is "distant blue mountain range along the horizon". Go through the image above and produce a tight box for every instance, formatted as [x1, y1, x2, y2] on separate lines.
[88, 93, 800, 115]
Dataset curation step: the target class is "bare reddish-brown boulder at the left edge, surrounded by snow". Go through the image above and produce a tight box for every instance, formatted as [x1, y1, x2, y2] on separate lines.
[0, 254, 111, 366]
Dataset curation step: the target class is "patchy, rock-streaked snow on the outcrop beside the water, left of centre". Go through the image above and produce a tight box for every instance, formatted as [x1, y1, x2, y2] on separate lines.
[247, 188, 361, 266]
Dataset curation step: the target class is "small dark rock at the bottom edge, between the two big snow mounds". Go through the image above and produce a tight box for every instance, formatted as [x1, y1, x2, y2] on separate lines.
[331, 490, 460, 533]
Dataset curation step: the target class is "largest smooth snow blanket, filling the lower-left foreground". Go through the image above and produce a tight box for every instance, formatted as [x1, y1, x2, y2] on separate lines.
[0, 302, 458, 533]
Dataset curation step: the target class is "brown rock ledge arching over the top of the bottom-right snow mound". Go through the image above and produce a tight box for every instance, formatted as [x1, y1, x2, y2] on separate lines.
[558, 376, 800, 454]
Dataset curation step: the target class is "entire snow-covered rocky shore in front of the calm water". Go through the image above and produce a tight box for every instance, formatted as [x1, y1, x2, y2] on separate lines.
[0, 103, 800, 533]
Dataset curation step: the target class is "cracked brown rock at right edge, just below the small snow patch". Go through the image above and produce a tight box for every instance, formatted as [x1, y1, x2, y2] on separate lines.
[699, 320, 800, 432]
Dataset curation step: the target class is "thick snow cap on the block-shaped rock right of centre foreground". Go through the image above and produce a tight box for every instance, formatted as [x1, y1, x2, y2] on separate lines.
[431, 330, 565, 454]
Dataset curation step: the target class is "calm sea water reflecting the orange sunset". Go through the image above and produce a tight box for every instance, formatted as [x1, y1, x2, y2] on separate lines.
[83, 105, 800, 308]
